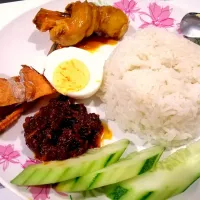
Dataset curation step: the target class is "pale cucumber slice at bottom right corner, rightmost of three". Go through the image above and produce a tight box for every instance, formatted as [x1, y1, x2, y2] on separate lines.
[105, 141, 200, 200]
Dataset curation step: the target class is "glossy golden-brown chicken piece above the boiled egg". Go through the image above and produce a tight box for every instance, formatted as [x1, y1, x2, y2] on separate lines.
[33, 1, 128, 46]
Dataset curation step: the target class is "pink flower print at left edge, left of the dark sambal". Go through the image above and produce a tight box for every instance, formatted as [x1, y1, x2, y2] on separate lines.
[0, 144, 20, 171]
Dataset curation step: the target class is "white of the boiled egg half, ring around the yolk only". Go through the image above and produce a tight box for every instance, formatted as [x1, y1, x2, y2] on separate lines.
[44, 47, 106, 99]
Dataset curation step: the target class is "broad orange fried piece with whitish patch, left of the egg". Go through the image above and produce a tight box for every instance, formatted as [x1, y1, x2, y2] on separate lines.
[0, 65, 55, 107]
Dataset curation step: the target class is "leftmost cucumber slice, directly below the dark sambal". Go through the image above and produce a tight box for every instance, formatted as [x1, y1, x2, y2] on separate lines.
[11, 139, 129, 186]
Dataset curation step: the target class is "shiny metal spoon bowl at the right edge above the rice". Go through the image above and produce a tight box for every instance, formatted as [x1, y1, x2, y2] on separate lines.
[180, 12, 200, 39]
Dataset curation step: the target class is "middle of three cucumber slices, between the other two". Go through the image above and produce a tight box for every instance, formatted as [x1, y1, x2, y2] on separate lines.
[56, 147, 164, 192]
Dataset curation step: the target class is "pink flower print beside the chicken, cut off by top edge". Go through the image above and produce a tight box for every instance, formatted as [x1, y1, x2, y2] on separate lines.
[114, 0, 140, 20]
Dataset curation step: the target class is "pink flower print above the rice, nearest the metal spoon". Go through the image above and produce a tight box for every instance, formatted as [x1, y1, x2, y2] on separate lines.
[140, 3, 174, 28]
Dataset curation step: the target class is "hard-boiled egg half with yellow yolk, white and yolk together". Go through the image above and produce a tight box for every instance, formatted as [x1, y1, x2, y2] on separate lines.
[44, 47, 105, 99]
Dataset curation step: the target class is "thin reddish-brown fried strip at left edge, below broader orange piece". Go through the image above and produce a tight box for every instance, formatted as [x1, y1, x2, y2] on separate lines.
[0, 104, 25, 133]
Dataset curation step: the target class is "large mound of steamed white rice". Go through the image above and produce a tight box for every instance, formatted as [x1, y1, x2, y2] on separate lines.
[98, 27, 200, 146]
